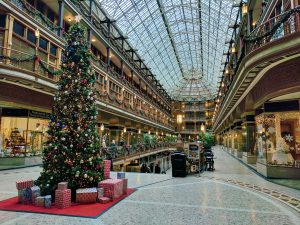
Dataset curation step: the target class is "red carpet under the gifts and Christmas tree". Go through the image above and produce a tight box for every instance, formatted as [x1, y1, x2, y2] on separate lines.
[0, 188, 136, 218]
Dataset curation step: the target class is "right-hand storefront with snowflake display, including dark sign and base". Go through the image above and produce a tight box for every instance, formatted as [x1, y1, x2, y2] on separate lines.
[255, 100, 300, 178]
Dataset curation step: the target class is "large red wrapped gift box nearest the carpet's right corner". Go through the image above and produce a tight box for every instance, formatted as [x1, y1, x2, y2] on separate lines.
[98, 179, 123, 200]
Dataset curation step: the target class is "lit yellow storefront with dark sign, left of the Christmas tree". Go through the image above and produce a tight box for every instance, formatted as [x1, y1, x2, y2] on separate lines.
[0, 108, 50, 158]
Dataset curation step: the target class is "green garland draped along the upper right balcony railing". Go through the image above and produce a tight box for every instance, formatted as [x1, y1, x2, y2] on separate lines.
[245, 6, 300, 43]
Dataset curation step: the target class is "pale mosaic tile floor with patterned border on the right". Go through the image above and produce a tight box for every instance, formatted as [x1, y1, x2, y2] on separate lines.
[0, 148, 300, 225]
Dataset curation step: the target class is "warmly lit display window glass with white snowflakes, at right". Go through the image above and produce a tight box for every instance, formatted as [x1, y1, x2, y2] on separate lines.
[255, 111, 300, 167]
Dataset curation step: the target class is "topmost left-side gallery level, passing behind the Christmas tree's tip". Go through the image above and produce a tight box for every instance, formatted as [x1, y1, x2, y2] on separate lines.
[1, 0, 170, 114]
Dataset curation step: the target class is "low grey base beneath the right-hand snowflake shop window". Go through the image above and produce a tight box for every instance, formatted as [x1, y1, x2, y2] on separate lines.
[256, 162, 300, 179]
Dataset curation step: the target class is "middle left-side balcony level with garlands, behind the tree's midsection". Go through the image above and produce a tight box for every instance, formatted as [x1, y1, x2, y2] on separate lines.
[0, 11, 173, 130]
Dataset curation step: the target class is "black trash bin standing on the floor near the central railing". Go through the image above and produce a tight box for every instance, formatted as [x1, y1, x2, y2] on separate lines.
[171, 152, 186, 177]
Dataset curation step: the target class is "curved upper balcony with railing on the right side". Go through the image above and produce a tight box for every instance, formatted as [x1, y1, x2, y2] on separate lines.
[213, 1, 300, 129]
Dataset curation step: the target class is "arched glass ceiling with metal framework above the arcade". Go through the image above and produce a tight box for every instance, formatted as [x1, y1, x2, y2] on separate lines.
[99, 0, 238, 101]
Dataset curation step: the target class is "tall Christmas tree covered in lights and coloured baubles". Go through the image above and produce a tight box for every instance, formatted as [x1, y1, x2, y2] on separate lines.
[36, 23, 103, 194]
